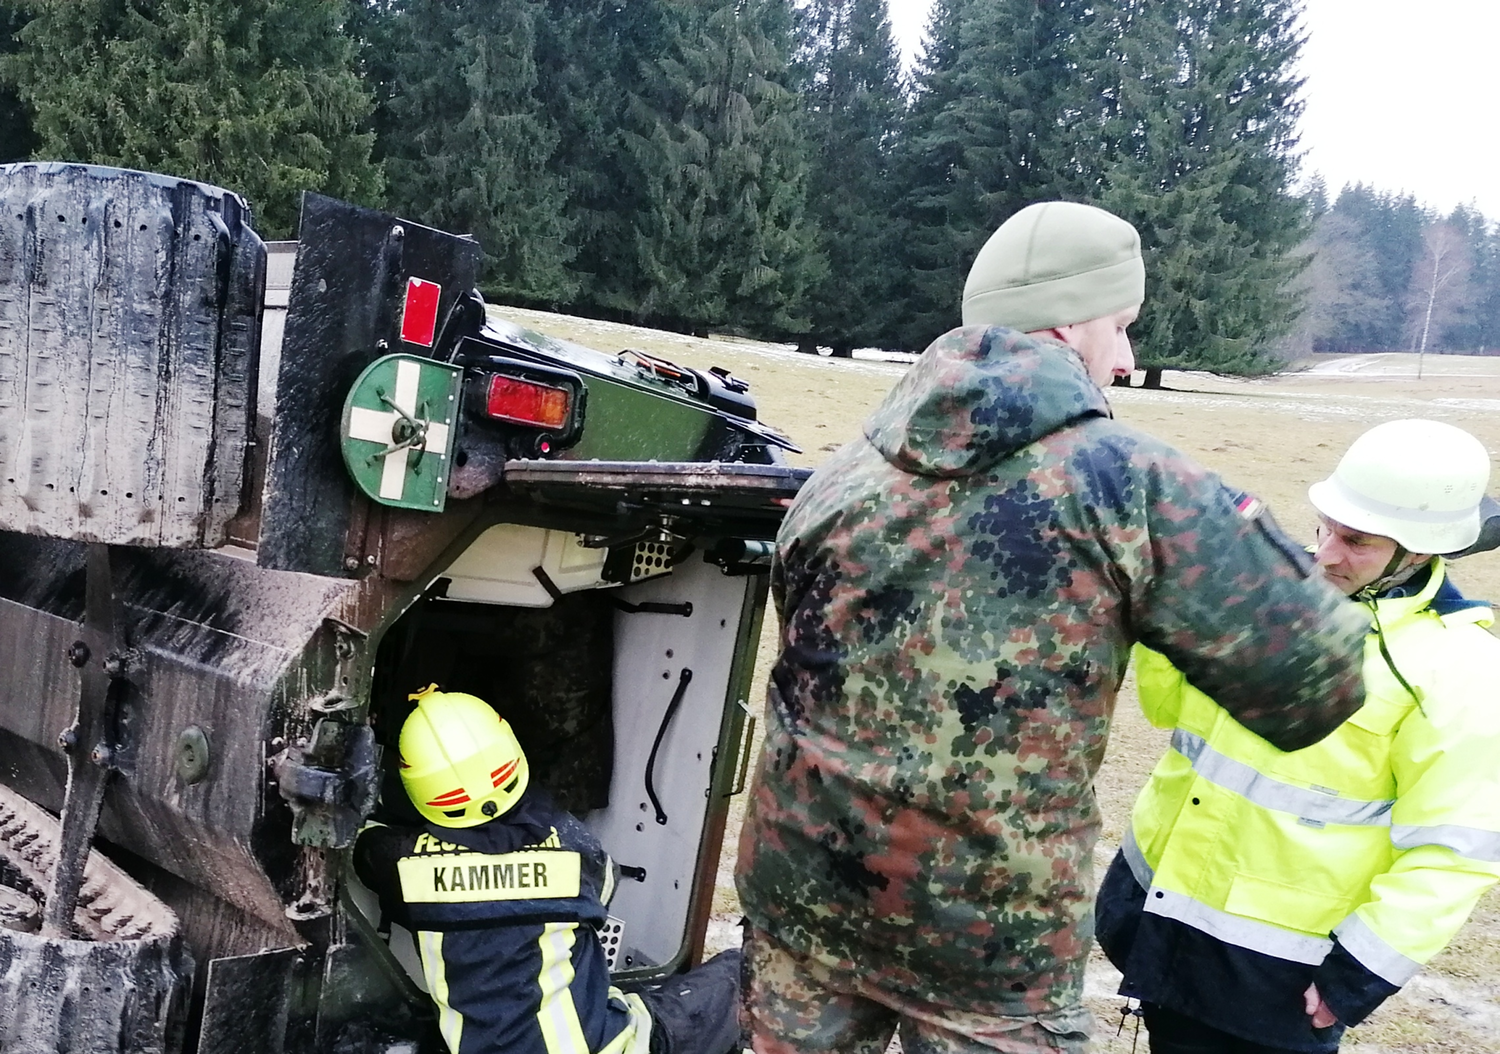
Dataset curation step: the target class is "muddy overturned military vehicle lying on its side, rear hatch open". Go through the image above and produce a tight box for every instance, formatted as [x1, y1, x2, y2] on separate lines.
[0, 163, 806, 1054]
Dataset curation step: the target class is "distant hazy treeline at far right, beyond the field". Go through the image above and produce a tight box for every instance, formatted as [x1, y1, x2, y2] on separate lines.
[1298, 180, 1500, 354]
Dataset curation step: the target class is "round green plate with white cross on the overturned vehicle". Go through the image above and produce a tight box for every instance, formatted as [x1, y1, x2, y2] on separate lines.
[339, 355, 464, 513]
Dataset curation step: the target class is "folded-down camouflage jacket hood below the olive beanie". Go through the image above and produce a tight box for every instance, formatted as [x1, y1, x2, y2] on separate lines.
[864, 325, 1110, 477]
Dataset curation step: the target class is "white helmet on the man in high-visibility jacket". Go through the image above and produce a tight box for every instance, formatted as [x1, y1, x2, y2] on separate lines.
[1308, 420, 1490, 553]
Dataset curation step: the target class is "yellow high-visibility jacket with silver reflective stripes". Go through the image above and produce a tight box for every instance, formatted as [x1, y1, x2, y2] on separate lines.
[1122, 558, 1500, 1024]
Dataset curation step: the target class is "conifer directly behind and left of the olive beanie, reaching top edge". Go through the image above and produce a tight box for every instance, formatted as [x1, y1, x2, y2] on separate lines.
[894, 0, 1092, 348]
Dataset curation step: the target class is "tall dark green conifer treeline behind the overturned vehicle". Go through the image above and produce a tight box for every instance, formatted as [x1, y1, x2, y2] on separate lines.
[0, 0, 1310, 372]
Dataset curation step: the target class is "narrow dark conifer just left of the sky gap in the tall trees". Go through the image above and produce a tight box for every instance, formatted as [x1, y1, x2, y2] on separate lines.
[800, 0, 903, 355]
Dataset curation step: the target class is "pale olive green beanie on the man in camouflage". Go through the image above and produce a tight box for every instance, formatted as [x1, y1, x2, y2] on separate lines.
[963, 201, 1146, 333]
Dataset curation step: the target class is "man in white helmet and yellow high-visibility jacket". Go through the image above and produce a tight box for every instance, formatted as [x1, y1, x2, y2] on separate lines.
[1097, 421, 1500, 1054]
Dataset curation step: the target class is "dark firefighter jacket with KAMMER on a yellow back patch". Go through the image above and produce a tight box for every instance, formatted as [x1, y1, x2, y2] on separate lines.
[354, 792, 651, 1054]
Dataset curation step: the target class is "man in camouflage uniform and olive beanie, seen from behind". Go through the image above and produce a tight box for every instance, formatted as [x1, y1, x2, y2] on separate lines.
[740, 202, 1365, 1054]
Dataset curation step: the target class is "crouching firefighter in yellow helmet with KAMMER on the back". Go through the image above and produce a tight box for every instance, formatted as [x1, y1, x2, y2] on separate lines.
[354, 687, 740, 1054]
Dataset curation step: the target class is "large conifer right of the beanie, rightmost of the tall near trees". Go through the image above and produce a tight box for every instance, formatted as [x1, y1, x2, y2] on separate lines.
[1080, 0, 1308, 385]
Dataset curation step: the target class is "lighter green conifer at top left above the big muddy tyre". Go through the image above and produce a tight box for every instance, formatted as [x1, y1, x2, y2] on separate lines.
[6, 0, 383, 237]
